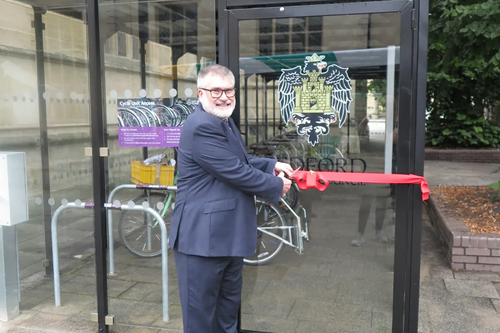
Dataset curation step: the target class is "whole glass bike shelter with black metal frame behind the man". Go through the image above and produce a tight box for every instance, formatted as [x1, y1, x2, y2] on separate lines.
[0, 0, 428, 333]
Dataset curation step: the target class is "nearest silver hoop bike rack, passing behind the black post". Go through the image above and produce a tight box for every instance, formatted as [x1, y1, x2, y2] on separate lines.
[52, 200, 169, 322]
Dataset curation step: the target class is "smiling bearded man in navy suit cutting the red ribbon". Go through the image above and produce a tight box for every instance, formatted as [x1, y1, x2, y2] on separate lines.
[169, 65, 293, 333]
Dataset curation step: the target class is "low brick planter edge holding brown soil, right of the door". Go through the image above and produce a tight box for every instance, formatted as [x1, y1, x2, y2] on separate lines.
[426, 197, 500, 272]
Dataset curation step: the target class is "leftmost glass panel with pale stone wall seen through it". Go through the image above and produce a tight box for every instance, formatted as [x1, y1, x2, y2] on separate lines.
[0, 0, 96, 331]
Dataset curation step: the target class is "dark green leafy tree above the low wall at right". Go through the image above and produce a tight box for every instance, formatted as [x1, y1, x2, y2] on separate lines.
[426, 0, 500, 148]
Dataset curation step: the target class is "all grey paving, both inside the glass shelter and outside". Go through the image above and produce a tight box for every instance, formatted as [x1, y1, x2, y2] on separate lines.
[0, 161, 500, 333]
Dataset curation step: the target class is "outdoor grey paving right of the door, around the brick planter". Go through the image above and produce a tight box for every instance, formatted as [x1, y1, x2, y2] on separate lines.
[419, 161, 500, 333]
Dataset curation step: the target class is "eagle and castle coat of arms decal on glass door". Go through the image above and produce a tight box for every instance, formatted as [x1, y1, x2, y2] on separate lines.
[278, 53, 352, 146]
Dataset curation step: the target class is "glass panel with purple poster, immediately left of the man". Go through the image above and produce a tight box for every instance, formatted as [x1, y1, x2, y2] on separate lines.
[99, 0, 217, 331]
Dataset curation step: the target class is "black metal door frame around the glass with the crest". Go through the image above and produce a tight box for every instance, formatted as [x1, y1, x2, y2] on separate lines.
[217, 0, 429, 333]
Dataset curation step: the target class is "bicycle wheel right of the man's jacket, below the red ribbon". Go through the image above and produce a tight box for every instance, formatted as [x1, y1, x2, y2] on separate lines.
[243, 198, 287, 266]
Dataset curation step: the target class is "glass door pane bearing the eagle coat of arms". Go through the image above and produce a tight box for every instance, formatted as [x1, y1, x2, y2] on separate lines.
[239, 14, 400, 333]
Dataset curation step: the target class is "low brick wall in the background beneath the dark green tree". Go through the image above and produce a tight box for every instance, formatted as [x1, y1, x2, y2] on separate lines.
[425, 149, 500, 163]
